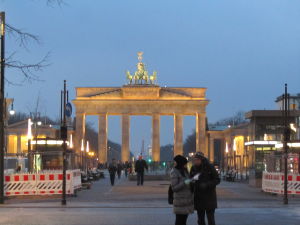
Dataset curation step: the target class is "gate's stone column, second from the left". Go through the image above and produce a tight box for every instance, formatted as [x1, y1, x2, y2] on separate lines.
[98, 114, 107, 163]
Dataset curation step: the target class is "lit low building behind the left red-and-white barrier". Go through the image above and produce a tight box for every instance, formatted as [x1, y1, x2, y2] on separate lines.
[5, 120, 74, 170]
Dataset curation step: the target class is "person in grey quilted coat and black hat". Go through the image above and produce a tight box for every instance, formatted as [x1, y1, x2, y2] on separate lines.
[170, 155, 194, 225]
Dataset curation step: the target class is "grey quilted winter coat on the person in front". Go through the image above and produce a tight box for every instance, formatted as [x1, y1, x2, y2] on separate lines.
[171, 168, 194, 215]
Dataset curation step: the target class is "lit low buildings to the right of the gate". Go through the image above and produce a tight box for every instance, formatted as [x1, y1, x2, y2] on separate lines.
[207, 95, 300, 186]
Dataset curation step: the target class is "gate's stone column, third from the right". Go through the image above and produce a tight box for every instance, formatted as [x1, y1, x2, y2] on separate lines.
[152, 114, 160, 162]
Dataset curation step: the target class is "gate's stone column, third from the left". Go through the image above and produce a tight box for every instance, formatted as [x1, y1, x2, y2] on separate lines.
[121, 114, 130, 162]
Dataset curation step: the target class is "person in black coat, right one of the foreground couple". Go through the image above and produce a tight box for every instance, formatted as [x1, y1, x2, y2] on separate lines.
[190, 152, 220, 225]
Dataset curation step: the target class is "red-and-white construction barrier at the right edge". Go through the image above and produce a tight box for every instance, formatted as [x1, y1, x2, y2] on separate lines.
[262, 172, 300, 194]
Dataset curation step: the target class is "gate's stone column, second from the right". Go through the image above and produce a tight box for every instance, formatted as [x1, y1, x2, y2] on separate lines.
[174, 114, 183, 156]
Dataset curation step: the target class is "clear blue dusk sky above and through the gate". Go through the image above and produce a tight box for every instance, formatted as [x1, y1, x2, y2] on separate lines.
[0, 0, 300, 155]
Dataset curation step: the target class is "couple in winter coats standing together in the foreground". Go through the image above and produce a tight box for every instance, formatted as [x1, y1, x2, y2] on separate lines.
[170, 152, 220, 225]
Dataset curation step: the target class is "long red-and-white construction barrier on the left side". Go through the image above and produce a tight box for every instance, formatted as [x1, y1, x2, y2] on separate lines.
[4, 170, 81, 196]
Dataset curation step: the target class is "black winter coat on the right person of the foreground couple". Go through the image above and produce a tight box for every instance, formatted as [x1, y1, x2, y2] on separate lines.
[190, 161, 220, 210]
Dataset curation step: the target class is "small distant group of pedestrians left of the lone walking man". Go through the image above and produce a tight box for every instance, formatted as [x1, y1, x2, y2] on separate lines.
[108, 159, 131, 186]
